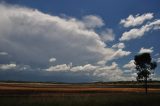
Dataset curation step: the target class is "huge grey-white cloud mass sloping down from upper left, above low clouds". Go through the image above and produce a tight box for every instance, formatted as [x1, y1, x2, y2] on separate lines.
[0, 4, 131, 67]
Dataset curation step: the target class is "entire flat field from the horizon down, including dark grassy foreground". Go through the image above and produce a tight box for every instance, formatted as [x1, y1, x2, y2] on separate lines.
[0, 82, 160, 106]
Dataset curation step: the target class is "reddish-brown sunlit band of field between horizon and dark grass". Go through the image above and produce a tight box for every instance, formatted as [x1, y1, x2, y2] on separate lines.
[0, 83, 160, 95]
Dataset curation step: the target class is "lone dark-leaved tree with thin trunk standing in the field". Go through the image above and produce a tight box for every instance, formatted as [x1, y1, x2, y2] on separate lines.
[134, 53, 157, 94]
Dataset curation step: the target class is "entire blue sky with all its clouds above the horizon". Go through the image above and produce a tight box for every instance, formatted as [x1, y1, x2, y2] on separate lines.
[0, 0, 160, 83]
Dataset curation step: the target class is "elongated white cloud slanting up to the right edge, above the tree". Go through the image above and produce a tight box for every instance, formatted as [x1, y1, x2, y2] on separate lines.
[119, 20, 160, 41]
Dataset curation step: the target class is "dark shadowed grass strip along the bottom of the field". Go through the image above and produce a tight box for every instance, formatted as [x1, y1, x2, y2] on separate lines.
[0, 93, 160, 106]
